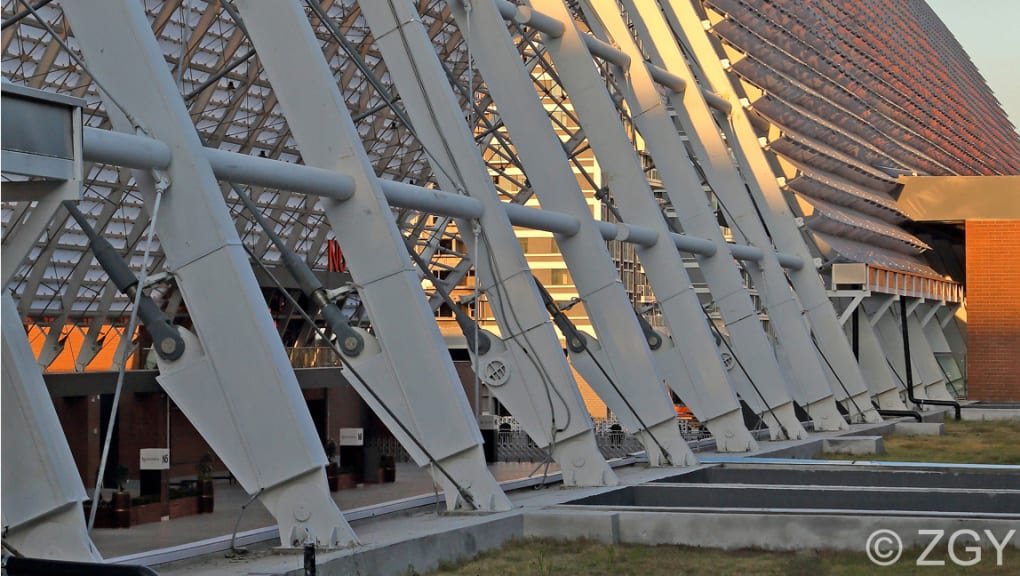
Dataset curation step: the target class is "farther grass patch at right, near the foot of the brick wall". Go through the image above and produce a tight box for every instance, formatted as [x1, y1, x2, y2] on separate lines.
[820, 418, 1020, 465]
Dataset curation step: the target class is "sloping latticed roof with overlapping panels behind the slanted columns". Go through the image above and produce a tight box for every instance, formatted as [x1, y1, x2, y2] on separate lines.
[2, 0, 1020, 369]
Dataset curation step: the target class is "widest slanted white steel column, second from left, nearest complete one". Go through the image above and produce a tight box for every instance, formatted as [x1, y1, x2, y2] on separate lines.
[62, 0, 356, 546]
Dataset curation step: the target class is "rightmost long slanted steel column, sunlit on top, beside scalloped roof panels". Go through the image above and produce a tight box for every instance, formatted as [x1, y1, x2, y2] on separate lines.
[659, 0, 875, 421]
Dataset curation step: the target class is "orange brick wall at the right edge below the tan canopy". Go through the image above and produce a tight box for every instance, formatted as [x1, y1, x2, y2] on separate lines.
[966, 220, 1020, 402]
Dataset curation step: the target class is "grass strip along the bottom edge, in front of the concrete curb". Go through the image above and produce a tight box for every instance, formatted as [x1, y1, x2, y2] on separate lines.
[430, 539, 1020, 576]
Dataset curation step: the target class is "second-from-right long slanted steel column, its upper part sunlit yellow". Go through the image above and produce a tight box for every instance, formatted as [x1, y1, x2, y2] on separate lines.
[625, 0, 881, 425]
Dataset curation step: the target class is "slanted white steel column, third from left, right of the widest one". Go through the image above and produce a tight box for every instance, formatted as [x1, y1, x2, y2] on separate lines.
[238, 0, 510, 503]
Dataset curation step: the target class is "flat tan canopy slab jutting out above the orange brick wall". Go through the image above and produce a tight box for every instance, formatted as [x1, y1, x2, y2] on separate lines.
[897, 176, 1020, 222]
